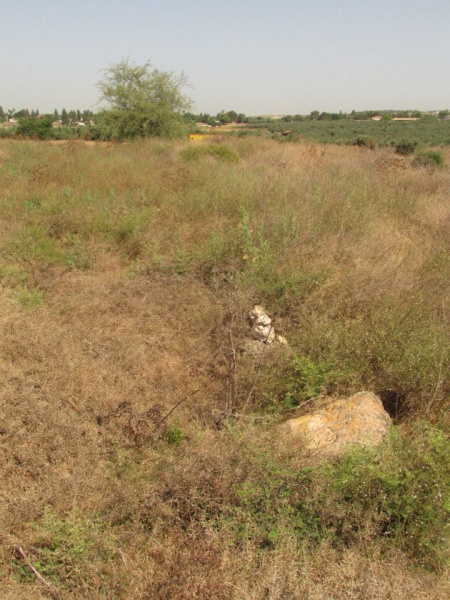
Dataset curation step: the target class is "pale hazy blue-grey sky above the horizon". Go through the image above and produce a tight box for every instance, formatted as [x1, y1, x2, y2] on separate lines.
[0, 0, 450, 115]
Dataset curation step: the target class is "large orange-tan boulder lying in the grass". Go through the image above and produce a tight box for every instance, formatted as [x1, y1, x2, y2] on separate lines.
[282, 392, 391, 458]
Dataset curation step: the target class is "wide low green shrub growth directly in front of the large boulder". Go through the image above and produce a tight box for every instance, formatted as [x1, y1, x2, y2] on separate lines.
[212, 422, 450, 571]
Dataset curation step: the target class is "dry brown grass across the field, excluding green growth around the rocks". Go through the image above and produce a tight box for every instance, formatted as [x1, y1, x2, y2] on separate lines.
[0, 139, 450, 600]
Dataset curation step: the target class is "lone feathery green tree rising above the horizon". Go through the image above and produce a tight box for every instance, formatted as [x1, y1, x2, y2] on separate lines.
[98, 59, 191, 139]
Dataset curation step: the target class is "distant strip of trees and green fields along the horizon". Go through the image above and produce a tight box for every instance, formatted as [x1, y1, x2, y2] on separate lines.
[0, 106, 450, 147]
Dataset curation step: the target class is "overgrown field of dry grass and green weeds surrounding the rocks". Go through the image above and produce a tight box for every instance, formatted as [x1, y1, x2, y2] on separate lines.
[0, 138, 450, 600]
